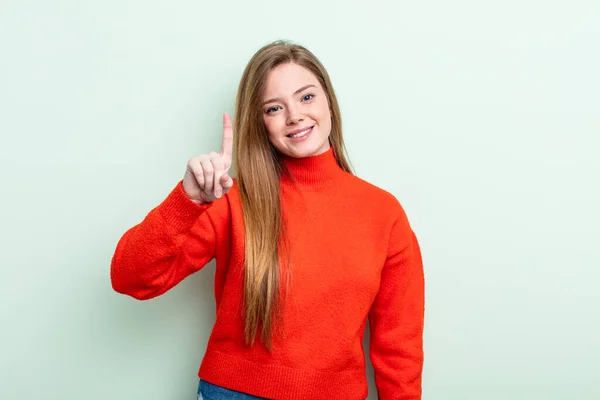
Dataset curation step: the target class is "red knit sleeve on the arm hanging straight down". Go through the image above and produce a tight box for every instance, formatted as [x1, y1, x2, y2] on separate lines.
[369, 203, 425, 400]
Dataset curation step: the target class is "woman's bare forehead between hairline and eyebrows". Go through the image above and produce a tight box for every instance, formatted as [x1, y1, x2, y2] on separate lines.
[264, 63, 321, 97]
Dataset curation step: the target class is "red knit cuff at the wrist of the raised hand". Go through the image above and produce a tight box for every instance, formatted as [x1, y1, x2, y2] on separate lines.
[157, 180, 213, 232]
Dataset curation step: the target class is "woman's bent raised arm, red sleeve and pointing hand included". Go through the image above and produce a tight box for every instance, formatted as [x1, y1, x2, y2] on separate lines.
[110, 114, 234, 300]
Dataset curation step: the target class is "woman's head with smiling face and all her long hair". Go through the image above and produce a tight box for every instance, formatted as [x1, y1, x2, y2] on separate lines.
[233, 41, 352, 349]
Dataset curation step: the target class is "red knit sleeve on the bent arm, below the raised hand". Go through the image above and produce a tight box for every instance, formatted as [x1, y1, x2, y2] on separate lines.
[110, 181, 216, 300]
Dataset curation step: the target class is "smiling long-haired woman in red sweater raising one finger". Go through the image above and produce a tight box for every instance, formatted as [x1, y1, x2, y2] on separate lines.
[111, 41, 424, 400]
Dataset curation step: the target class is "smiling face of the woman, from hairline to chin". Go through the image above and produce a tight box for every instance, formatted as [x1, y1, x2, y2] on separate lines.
[262, 63, 331, 158]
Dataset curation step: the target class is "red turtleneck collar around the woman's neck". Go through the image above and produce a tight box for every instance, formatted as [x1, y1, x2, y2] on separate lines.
[280, 147, 344, 189]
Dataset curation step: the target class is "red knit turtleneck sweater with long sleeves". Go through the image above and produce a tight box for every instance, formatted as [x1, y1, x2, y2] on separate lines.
[111, 148, 424, 400]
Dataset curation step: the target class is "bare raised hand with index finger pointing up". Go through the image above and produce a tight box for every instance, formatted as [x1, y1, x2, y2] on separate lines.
[183, 114, 233, 204]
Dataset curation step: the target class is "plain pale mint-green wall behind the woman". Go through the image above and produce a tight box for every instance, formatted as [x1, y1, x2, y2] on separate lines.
[0, 0, 600, 400]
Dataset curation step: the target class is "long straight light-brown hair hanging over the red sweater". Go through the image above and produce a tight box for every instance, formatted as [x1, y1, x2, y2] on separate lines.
[234, 41, 353, 351]
